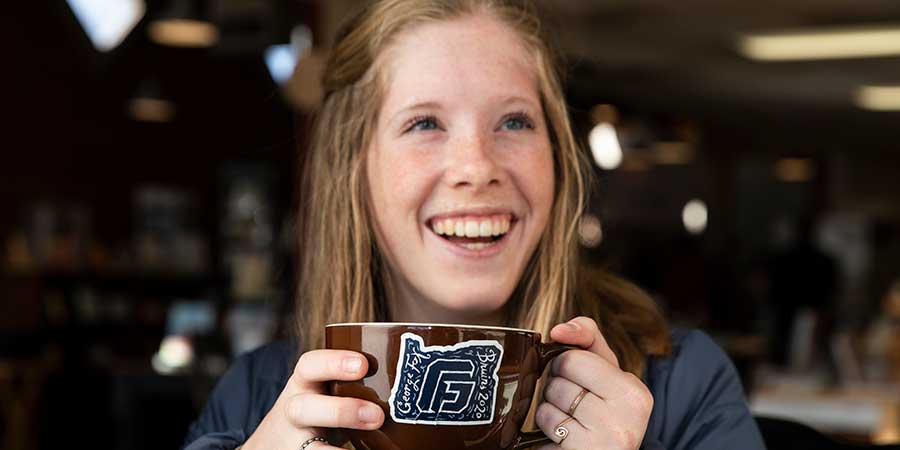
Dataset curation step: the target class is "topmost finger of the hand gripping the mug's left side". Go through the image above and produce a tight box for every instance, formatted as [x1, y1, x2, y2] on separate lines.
[291, 349, 369, 392]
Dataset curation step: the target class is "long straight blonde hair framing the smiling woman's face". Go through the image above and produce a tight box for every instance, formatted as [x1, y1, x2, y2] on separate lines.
[295, 0, 668, 376]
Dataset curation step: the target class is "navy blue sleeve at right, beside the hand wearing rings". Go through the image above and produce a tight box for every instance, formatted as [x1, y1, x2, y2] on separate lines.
[641, 331, 766, 450]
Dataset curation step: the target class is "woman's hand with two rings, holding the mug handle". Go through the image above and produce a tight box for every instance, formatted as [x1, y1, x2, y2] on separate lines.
[535, 317, 653, 450]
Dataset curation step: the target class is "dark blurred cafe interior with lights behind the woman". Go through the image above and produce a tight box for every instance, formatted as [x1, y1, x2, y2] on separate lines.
[0, 0, 900, 450]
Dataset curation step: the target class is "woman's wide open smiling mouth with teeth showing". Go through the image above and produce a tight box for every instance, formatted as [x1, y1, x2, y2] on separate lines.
[428, 214, 515, 250]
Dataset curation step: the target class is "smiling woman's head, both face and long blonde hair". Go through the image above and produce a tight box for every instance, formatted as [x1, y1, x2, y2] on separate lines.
[296, 1, 669, 374]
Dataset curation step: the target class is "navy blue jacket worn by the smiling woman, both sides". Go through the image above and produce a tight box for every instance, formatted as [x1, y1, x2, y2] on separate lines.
[184, 330, 766, 450]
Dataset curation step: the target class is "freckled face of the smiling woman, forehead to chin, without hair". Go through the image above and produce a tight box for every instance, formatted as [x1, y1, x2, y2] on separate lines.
[366, 16, 554, 320]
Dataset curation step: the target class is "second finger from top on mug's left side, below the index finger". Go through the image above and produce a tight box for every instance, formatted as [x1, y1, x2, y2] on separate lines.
[285, 392, 384, 430]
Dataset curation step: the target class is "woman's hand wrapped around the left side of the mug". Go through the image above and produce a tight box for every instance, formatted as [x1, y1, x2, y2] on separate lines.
[241, 350, 384, 450]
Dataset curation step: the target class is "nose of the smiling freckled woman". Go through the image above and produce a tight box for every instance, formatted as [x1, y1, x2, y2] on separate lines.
[446, 135, 502, 190]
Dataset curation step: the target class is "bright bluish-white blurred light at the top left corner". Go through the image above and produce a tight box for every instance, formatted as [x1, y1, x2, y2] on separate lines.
[66, 0, 147, 52]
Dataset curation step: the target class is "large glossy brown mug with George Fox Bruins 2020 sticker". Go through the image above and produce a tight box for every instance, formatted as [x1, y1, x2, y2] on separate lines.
[325, 322, 571, 450]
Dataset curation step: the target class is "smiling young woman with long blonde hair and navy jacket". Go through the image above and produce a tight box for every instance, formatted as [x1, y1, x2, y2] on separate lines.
[179, 0, 764, 450]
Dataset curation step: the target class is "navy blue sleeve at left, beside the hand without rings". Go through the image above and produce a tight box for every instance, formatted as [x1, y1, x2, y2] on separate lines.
[182, 345, 287, 450]
